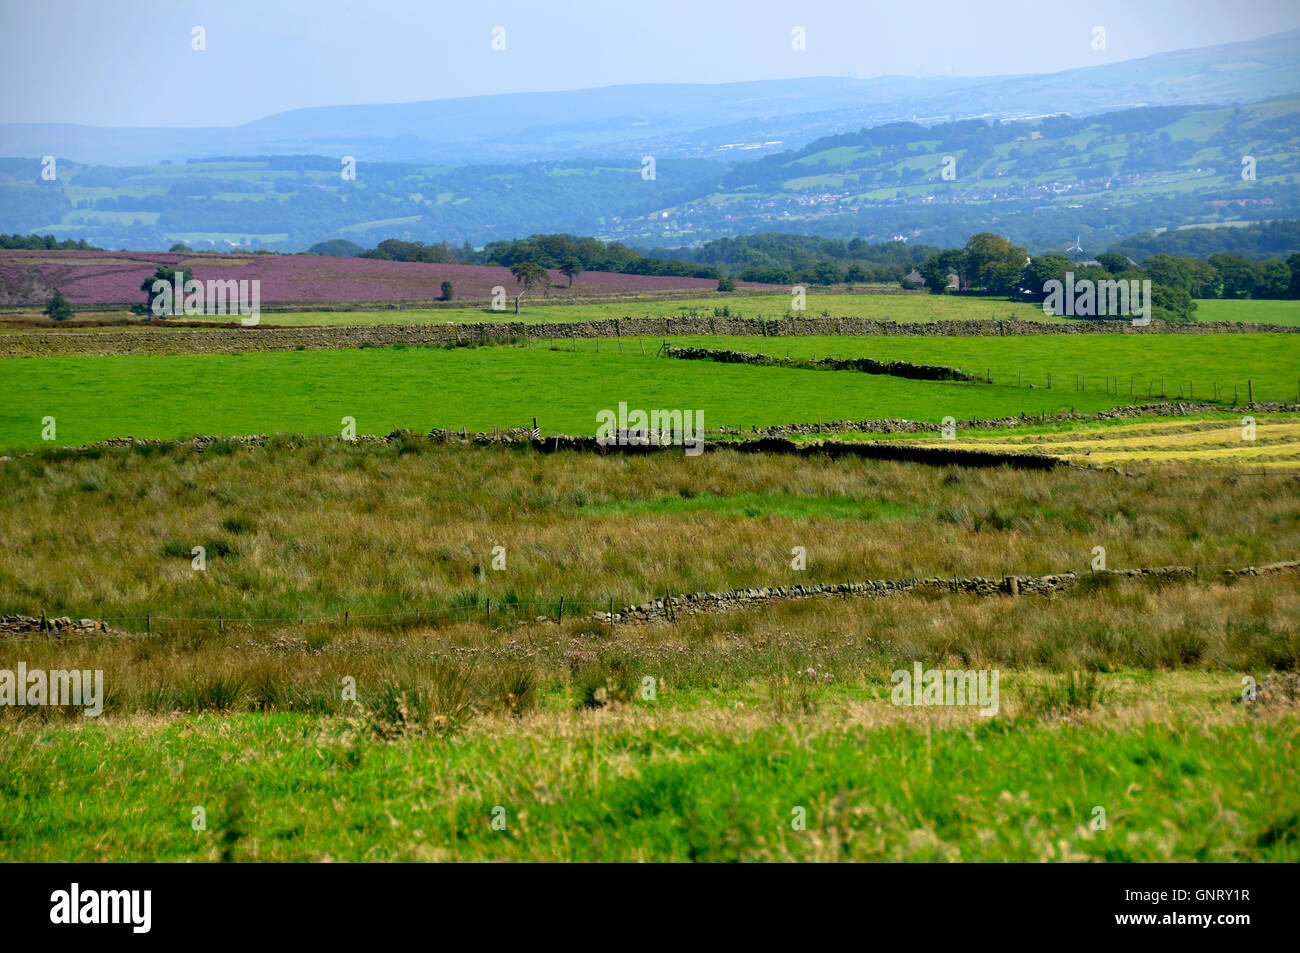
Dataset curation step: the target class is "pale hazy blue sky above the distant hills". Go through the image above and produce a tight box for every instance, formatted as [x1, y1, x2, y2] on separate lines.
[0, 0, 1300, 126]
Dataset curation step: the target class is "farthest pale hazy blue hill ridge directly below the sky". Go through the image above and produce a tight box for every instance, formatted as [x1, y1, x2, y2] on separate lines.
[0, 30, 1300, 165]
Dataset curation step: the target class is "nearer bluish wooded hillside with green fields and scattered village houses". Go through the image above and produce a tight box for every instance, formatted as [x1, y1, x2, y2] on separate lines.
[0, 95, 1300, 254]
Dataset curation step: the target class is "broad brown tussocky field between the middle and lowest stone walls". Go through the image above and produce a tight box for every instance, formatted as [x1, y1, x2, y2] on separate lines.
[0, 438, 1300, 632]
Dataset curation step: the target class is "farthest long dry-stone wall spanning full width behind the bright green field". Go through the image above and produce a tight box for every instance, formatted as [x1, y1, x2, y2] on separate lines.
[0, 316, 1300, 358]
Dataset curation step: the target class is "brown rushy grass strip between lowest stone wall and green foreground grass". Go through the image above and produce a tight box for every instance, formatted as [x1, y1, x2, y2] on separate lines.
[0, 576, 1300, 722]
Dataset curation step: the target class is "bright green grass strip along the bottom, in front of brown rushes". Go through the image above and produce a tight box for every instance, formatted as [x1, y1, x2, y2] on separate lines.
[0, 691, 1300, 862]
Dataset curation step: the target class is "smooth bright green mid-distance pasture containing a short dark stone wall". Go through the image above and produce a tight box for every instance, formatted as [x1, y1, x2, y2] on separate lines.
[0, 334, 1300, 449]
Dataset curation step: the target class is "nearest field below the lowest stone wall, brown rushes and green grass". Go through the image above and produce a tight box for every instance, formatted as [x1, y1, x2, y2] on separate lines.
[0, 577, 1300, 862]
